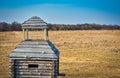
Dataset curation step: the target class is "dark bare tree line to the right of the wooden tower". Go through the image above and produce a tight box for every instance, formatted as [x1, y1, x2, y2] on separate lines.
[49, 23, 120, 30]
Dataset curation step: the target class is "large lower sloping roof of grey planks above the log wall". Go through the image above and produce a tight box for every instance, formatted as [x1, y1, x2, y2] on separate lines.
[9, 40, 59, 60]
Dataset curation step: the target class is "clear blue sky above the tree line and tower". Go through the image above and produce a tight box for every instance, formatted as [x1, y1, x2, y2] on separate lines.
[0, 0, 120, 25]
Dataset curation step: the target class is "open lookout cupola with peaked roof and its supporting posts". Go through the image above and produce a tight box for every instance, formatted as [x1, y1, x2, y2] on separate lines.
[22, 16, 49, 40]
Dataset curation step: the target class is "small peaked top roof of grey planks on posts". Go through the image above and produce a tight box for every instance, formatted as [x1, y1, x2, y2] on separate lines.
[22, 16, 48, 29]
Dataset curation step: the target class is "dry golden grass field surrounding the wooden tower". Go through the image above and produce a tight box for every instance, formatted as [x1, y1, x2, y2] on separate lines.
[0, 30, 120, 78]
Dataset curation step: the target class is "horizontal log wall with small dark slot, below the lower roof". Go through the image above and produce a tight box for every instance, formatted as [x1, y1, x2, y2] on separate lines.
[9, 59, 59, 78]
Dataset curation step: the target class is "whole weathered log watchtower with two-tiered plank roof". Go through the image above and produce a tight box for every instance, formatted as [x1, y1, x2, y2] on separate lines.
[9, 16, 59, 78]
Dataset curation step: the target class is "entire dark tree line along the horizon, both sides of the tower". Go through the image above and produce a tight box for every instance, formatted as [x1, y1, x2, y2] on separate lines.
[0, 22, 120, 31]
